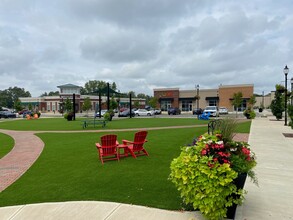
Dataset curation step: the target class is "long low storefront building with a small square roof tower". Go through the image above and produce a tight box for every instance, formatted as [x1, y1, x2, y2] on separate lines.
[19, 84, 146, 112]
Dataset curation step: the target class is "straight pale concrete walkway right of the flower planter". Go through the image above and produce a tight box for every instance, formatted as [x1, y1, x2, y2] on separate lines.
[236, 117, 293, 220]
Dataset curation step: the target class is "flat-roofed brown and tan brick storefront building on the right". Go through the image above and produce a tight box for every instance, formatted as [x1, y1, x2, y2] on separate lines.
[154, 84, 254, 112]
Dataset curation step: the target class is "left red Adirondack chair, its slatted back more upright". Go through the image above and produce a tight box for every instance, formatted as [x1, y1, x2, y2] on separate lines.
[96, 134, 119, 164]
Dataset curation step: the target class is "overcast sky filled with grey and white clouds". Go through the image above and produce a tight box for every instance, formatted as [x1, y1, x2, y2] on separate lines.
[0, 0, 293, 96]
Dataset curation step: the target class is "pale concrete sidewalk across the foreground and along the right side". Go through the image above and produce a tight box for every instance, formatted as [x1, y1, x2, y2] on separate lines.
[0, 117, 293, 220]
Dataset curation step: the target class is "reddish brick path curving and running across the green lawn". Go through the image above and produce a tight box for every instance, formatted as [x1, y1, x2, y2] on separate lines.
[0, 125, 249, 192]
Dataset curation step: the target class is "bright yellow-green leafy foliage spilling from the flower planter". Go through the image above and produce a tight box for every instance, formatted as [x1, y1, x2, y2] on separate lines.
[170, 137, 244, 219]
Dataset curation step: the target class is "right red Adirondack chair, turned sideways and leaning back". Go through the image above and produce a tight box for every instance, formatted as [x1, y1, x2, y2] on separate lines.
[122, 131, 149, 158]
